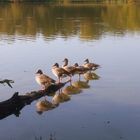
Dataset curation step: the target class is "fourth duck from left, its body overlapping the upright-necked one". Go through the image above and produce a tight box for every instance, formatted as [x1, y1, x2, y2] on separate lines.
[73, 63, 89, 80]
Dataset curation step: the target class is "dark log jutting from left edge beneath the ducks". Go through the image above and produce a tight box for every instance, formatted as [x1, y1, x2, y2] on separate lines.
[0, 81, 69, 119]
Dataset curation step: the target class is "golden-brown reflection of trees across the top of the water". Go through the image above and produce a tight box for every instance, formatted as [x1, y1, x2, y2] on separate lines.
[0, 4, 140, 41]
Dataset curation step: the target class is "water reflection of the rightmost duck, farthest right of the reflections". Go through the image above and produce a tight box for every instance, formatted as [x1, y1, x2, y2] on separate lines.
[83, 72, 100, 80]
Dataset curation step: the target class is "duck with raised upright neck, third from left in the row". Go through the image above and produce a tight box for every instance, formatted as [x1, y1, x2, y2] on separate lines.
[62, 58, 76, 75]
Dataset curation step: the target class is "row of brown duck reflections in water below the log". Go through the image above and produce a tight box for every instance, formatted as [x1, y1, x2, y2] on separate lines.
[36, 72, 100, 114]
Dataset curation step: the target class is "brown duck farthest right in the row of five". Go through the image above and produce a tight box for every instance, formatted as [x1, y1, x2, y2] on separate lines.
[83, 59, 100, 71]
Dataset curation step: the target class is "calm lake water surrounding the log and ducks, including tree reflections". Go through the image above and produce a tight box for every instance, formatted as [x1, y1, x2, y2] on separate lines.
[0, 3, 140, 140]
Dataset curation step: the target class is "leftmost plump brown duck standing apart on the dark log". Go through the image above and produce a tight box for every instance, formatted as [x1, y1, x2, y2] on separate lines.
[35, 69, 56, 90]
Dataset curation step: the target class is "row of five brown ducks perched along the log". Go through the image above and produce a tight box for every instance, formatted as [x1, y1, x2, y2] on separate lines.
[35, 58, 100, 90]
